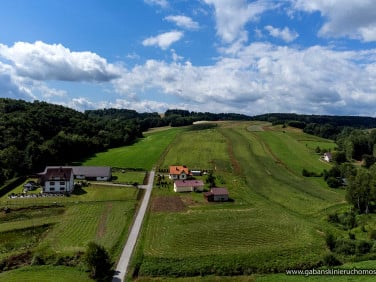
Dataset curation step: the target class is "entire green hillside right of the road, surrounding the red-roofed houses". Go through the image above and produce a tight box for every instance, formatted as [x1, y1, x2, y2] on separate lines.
[133, 123, 352, 277]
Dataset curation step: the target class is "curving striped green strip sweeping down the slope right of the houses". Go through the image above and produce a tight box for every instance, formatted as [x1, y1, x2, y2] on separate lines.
[224, 128, 344, 214]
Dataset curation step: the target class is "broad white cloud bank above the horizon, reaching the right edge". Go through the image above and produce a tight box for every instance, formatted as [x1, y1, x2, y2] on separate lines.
[114, 43, 376, 115]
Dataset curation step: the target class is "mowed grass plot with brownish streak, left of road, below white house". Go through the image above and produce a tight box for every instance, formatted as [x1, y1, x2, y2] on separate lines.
[41, 201, 135, 253]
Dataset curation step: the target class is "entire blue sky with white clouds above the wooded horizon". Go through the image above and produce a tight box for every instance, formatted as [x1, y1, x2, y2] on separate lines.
[0, 0, 376, 116]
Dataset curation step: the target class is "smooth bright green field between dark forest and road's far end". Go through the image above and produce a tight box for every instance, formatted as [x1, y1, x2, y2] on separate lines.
[82, 128, 185, 170]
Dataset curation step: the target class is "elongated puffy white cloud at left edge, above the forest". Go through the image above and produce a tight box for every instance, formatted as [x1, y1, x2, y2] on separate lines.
[0, 41, 119, 82]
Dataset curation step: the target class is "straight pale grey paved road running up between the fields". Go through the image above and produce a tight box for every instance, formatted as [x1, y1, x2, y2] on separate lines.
[112, 170, 155, 282]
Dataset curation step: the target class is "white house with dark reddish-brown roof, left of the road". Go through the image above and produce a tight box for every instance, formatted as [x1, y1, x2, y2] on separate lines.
[41, 167, 74, 193]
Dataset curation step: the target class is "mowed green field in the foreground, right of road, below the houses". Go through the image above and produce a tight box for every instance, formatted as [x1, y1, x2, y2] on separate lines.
[145, 206, 324, 258]
